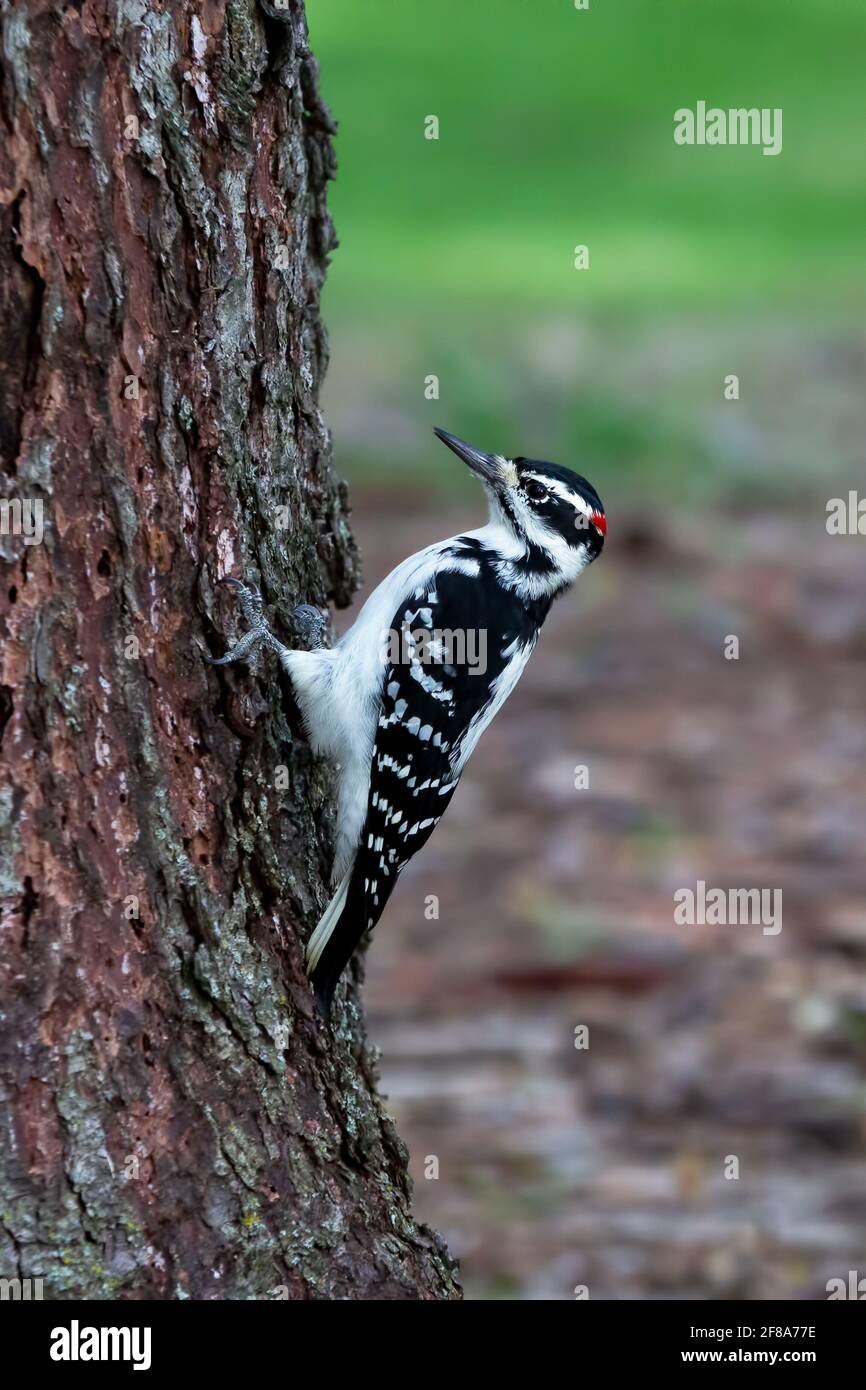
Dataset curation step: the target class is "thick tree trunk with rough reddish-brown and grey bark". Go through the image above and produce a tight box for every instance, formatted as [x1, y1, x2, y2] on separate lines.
[0, 0, 459, 1298]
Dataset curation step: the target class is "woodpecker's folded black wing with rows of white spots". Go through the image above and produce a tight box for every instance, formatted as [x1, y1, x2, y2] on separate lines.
[313, 553, 538, 1008]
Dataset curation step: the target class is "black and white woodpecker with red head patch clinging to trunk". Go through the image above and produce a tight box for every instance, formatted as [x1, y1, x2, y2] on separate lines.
[207, 430, 607, 1019]
